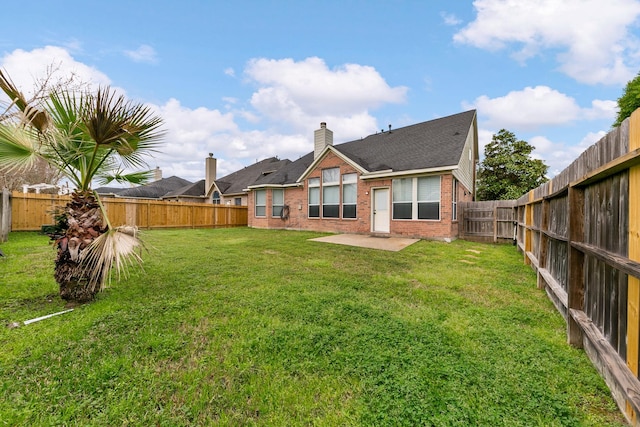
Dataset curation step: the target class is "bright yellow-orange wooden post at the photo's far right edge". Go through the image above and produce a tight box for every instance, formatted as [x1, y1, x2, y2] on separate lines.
[626, 110, 640, 422]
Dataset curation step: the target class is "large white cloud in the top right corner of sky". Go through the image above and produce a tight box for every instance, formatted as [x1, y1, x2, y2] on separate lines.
[454, 0, 640, 84]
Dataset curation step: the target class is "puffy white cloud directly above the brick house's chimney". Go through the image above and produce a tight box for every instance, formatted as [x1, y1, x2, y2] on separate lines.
[245, 57, 408, 138]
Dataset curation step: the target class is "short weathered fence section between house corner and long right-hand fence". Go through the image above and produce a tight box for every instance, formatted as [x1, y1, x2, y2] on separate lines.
[458, 200, 516, 243]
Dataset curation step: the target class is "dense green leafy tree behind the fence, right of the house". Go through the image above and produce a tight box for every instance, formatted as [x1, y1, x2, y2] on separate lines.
[476, 129, 549, 200]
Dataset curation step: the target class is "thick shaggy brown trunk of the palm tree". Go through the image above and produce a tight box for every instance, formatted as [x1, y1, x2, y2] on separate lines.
[55, 191, 107, 302]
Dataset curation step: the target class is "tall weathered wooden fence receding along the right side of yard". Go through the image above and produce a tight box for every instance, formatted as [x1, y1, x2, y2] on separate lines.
[515, 110, 640, 425]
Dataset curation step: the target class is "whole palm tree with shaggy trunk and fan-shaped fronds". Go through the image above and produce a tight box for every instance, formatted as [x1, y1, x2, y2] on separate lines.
[0, 72, 164, 302]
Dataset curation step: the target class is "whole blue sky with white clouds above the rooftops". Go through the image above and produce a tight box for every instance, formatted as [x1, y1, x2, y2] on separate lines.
[0, 0, 640, 181]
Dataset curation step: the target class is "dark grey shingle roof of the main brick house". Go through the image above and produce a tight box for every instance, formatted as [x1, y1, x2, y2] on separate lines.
[245, 110, 476, 188]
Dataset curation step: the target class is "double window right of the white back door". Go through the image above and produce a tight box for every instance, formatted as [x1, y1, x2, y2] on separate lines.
[393, 176, 440, 220]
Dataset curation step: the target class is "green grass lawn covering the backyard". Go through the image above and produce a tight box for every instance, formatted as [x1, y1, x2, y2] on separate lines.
[0, 228, 624, 426]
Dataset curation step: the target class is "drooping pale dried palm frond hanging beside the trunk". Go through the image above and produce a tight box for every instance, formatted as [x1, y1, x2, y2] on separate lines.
[80, 226, 144, 291]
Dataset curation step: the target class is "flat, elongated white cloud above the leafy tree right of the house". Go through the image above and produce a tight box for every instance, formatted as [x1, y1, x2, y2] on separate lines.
[464, 86, 617, 131]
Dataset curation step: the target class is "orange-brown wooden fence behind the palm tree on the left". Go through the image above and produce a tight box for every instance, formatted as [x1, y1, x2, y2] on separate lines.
[2, 192, 247, 231]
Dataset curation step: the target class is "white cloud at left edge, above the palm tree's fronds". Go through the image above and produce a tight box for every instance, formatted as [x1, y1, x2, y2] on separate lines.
[0, 46, 111, 98]
